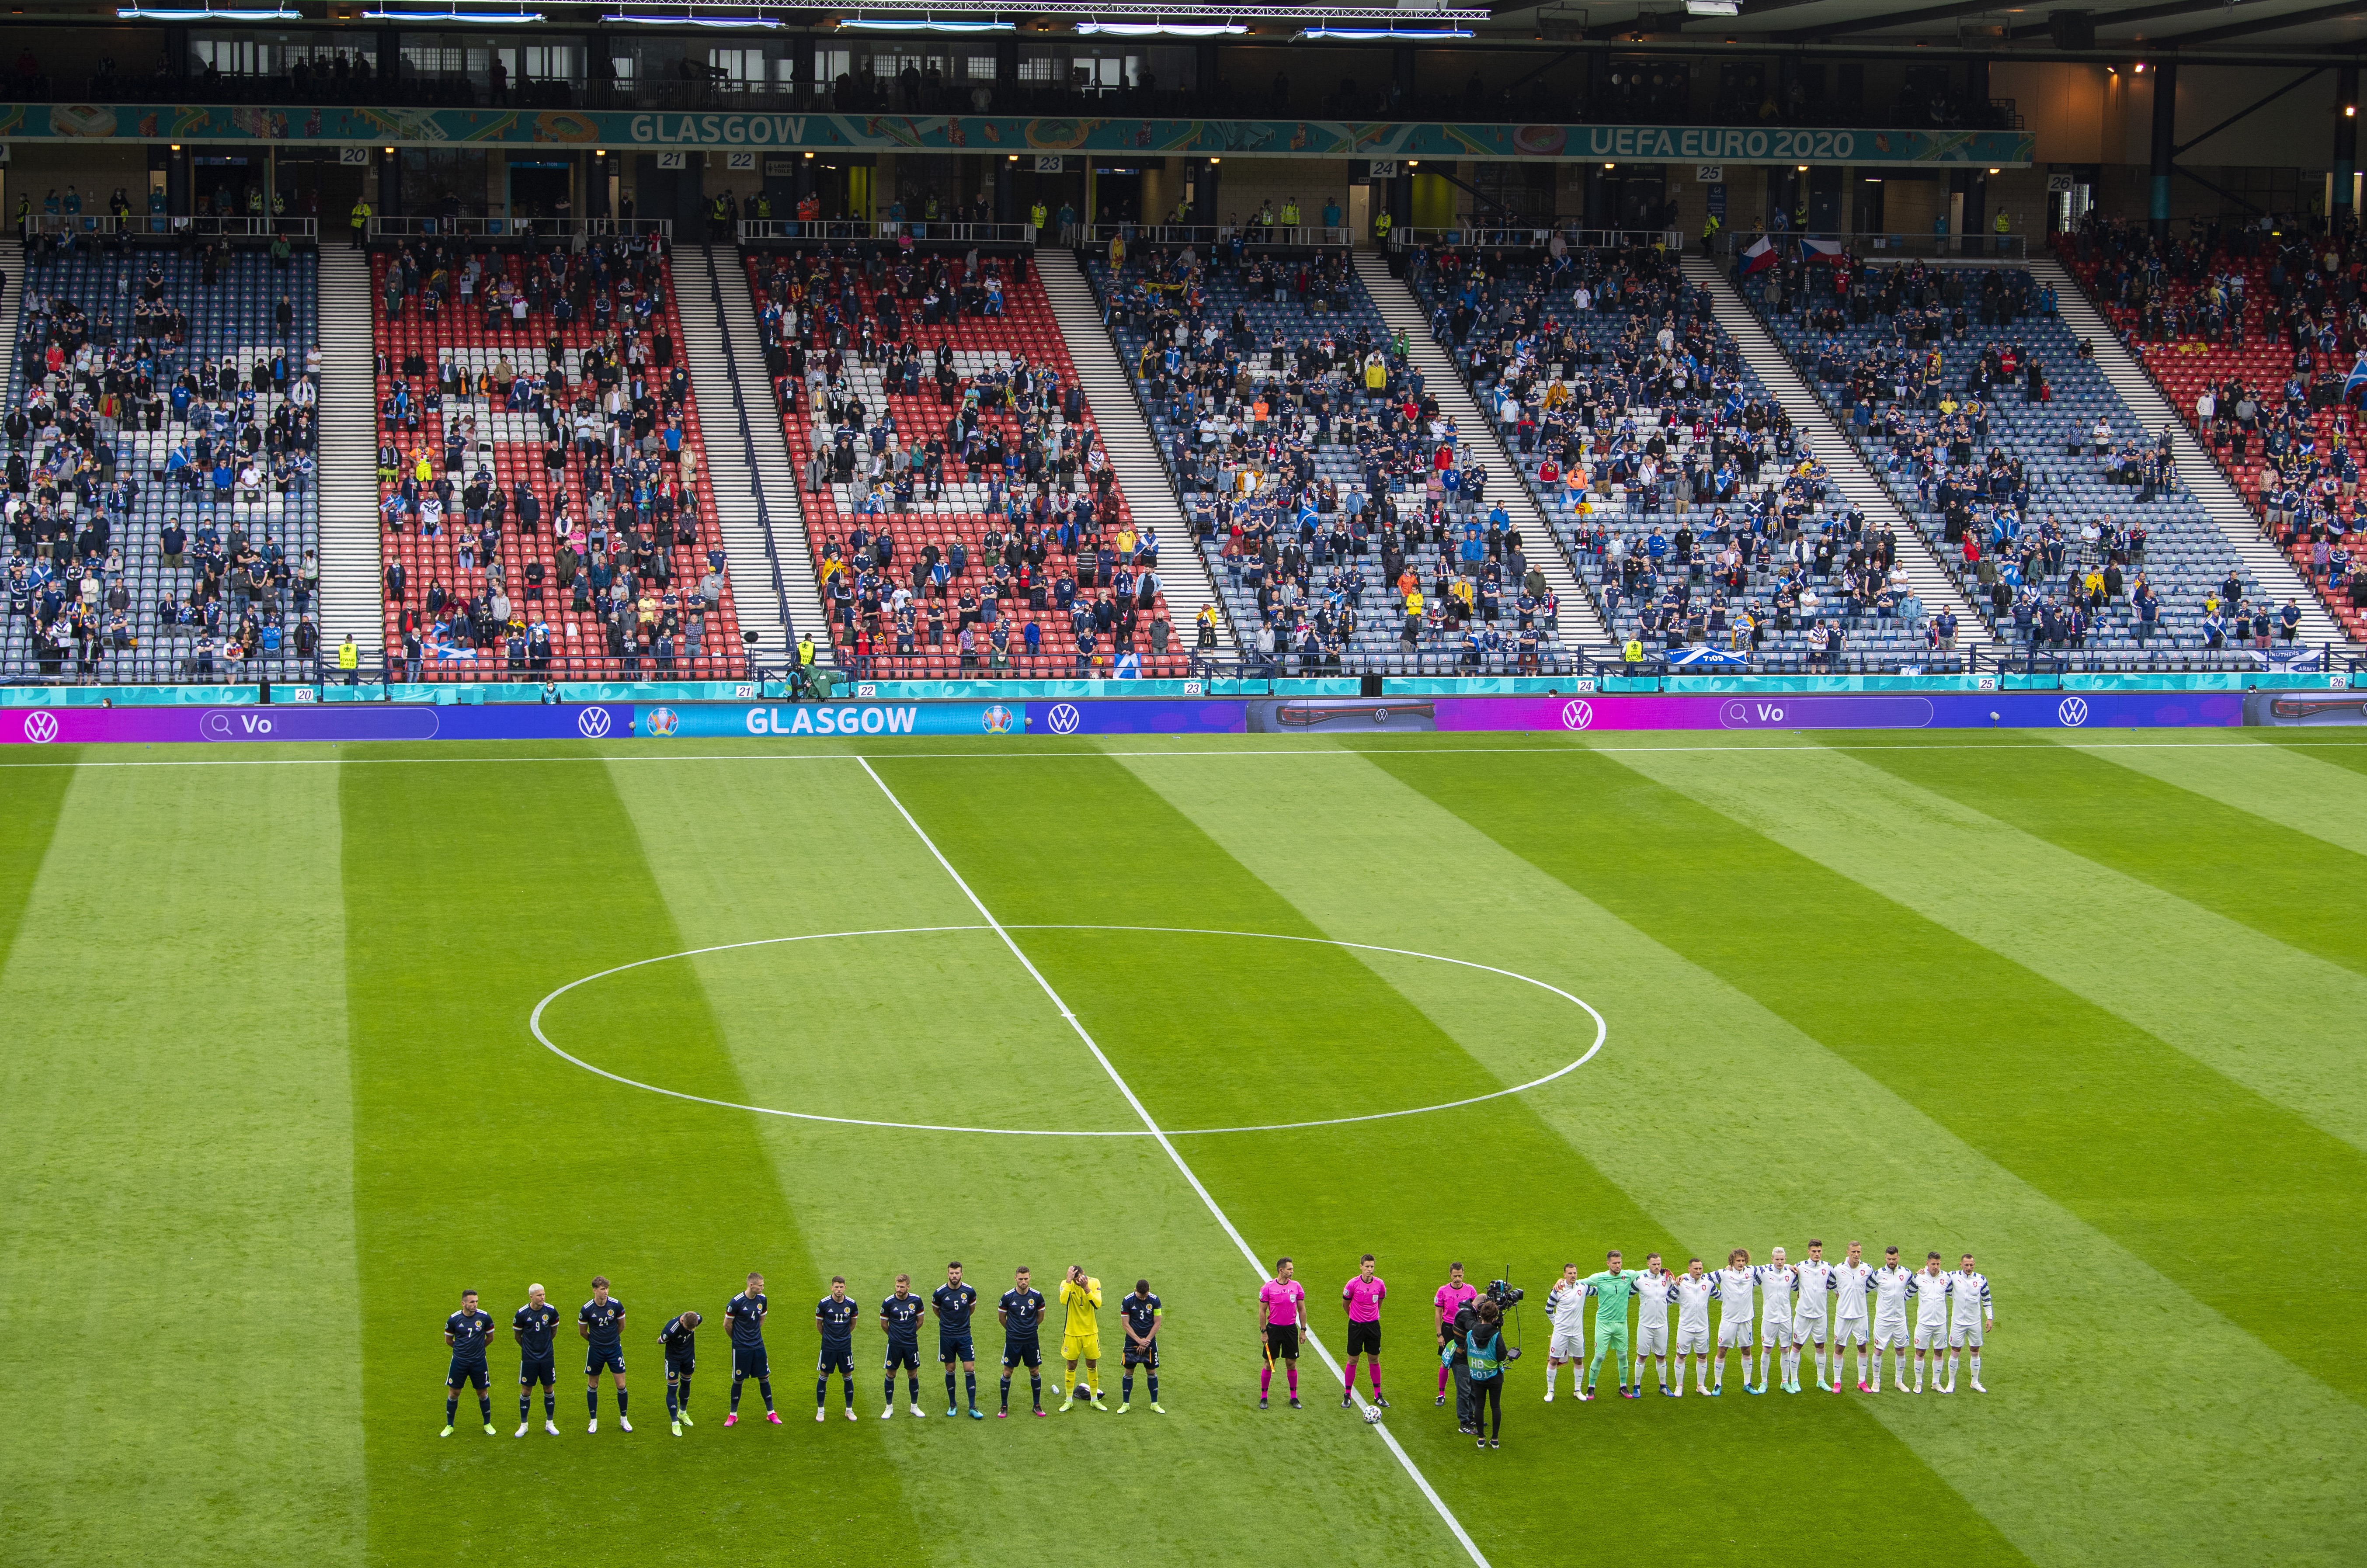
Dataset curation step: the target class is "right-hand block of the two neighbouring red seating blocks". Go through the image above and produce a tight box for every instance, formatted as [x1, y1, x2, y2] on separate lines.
[746, 251, 1193, 679]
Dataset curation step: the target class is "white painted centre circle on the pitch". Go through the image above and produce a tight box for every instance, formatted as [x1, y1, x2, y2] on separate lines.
[528, 925, 1609, 1138]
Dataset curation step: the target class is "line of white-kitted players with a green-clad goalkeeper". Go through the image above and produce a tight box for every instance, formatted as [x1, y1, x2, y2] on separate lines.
[1505, 1242, 1998, 1400]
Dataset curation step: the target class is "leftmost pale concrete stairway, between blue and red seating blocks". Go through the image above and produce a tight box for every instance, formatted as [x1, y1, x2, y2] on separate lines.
[315, 246, 383, 670]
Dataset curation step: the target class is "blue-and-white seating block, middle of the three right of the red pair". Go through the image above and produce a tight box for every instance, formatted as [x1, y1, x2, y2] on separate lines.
[1411, 251, 1953, 672]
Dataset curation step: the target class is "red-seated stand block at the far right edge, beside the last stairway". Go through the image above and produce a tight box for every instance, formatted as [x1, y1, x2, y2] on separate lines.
[2057, 232, 2367, 638]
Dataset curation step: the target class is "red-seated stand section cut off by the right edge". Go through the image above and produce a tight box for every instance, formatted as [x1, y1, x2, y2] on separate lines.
[2057, 220, 2367, 641]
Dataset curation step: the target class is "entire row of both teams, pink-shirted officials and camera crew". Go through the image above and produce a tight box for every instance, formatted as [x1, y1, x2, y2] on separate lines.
[443, 1239, 1995, 1445]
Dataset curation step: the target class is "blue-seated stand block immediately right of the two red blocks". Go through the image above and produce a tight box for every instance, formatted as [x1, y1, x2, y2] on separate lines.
[1089, 246, 1579, 674]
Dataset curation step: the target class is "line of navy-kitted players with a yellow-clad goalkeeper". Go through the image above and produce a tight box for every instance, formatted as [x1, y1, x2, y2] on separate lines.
[440, 1260, 1167, 1438]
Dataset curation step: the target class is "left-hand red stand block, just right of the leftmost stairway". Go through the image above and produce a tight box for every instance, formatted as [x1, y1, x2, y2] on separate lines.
[372, 236, 748, 679]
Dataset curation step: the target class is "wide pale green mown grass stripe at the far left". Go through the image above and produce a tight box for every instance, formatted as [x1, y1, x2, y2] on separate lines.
[0, 769, 365, 1563]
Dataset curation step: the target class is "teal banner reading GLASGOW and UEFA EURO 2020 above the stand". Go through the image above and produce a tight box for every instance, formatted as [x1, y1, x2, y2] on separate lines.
[0, 104, 2038, 168]
